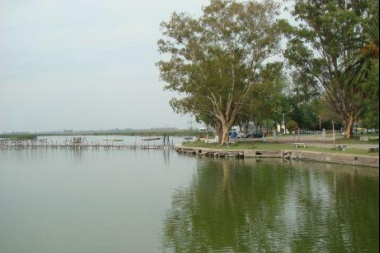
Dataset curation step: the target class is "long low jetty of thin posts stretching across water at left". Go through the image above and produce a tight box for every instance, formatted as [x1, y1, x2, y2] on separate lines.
[0, 136, 174, 150]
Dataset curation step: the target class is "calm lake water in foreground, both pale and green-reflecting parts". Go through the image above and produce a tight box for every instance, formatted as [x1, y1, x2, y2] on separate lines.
[0, 141, 379, 253]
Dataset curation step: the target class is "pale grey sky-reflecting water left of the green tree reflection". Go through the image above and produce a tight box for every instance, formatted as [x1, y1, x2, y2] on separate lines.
[0, 148, 196, 253]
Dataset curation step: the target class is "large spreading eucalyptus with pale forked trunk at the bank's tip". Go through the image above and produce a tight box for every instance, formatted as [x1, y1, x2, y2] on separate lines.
[157, 0, 280, 144]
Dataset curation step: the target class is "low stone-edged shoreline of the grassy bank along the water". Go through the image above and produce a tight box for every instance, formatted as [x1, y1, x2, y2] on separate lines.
[174, 145, 379, 168]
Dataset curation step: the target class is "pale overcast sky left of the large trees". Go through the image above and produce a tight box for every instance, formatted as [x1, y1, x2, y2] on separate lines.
[0, 0, 209, 133]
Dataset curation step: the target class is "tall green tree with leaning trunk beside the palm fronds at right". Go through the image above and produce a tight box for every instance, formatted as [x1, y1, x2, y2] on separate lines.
[281, 0, 372, 138]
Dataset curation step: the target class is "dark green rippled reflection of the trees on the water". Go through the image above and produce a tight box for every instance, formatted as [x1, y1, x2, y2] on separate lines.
[163, 159, 379, 253]
